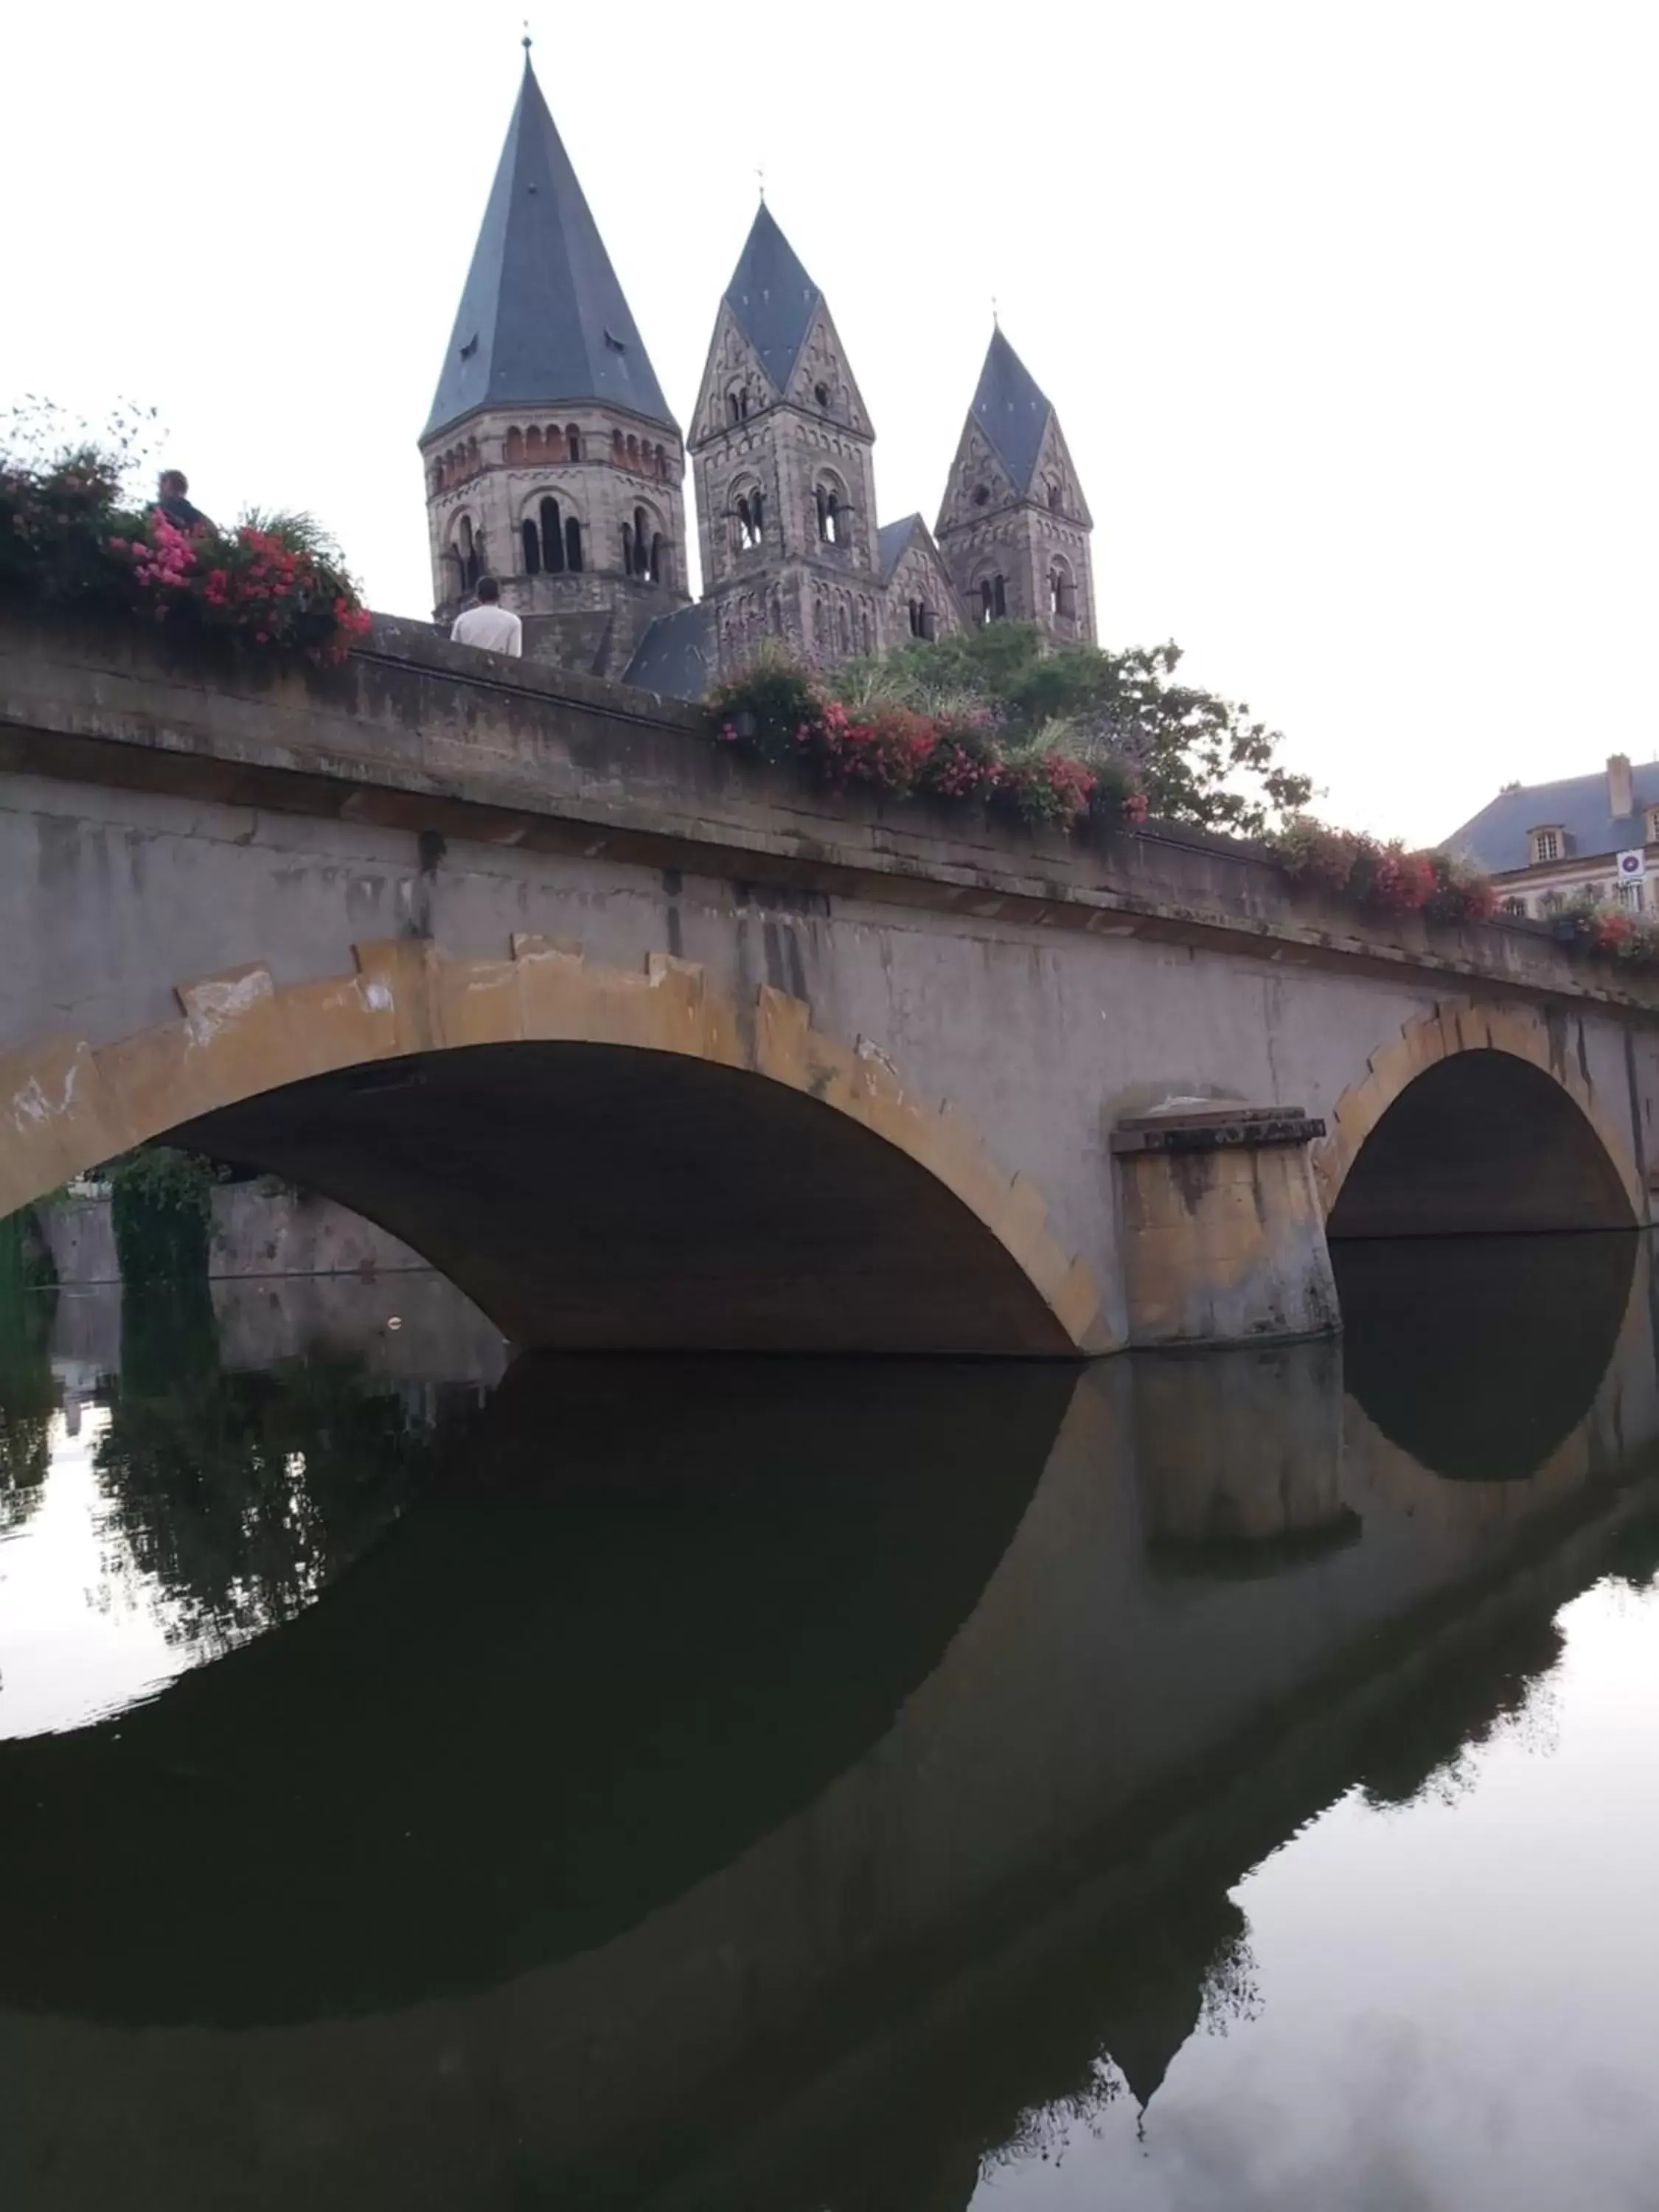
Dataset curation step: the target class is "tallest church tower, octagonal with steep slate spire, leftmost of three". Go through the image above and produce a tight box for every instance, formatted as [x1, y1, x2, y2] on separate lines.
[420, 40, 688, 677]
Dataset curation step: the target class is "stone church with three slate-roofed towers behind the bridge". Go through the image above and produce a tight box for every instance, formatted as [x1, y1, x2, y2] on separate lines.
[420, 46, 1095, 699]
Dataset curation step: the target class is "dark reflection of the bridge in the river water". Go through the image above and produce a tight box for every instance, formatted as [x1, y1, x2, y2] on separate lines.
[0, 1237, 1659, 2212]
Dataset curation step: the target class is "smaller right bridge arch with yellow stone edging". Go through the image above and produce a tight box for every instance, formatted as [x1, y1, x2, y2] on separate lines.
[1314, 1002, 1648, 1241]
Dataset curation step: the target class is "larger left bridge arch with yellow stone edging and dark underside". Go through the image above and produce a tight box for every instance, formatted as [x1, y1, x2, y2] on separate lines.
[0, 936, 1110, 1356]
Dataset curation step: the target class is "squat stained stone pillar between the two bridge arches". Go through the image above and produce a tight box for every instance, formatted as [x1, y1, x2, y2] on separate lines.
[1113, 1099, 1340, 1345]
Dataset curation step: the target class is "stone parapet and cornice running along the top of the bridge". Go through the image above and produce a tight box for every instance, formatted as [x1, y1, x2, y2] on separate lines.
[0, 611, 1659, 1018]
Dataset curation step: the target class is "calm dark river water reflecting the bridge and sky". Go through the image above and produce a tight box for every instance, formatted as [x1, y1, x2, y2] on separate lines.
[0, 1237, 1659, 2212]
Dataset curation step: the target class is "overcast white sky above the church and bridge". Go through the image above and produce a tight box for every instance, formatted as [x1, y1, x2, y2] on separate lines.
[0, 0, 1659, 838]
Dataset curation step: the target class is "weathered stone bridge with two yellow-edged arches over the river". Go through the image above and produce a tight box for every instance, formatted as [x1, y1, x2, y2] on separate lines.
[0, 615, 1659, 1356]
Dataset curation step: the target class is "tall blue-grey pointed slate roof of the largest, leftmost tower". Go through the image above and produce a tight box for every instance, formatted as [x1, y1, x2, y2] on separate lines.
[422, 53, 677, 438]
